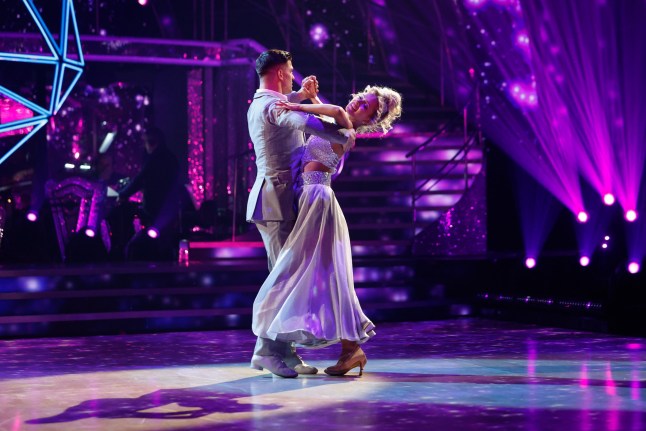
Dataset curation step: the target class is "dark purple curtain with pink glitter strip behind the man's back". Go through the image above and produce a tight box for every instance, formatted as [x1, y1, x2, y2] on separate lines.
[188, 63, 257, 233]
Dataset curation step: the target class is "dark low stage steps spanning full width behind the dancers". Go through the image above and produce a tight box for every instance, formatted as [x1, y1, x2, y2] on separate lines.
[0, 256, 646, 338]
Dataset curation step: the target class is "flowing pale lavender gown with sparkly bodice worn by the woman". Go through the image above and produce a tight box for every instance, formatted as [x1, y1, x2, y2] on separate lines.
[252, 136, 375, 348]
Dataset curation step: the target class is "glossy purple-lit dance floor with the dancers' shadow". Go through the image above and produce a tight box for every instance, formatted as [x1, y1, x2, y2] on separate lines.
[0, 320, 646, 431]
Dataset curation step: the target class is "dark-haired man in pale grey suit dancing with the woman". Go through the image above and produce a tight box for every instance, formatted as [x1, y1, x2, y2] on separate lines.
[247, 49, 355, 377]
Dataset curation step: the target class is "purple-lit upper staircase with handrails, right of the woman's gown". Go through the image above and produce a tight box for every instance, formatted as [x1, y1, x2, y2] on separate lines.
[333, 125, 483, 256]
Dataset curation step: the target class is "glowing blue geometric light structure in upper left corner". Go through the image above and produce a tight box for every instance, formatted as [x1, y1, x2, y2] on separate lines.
[0, 0, 85, 165]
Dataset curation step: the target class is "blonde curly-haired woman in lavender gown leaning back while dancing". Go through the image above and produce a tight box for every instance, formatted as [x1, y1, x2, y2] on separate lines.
[252, 86, 401, 375]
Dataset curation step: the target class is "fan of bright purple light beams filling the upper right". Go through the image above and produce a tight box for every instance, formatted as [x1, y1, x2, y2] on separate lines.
[464, 0, 646, 255]
